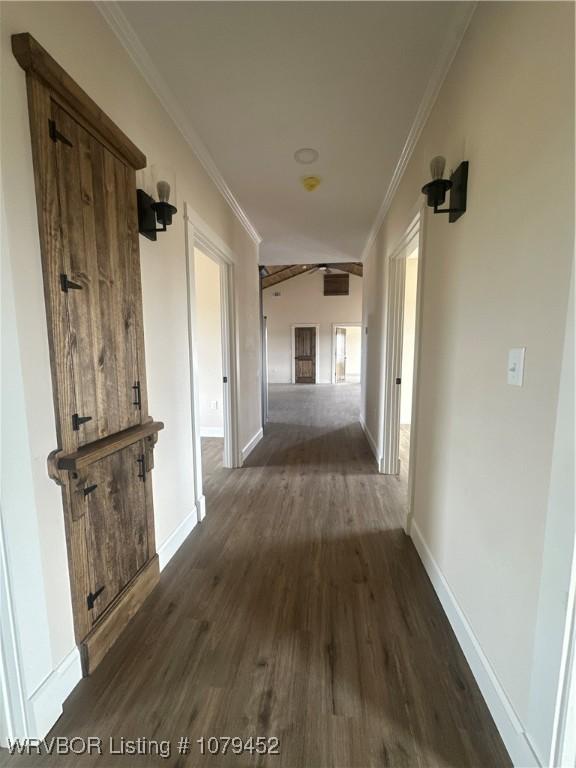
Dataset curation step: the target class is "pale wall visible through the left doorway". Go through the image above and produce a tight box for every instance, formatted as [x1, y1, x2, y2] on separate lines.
[194, 248, 224, 437]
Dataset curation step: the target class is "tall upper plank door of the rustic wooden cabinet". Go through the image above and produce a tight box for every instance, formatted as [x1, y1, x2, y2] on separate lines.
[52, 102, 144, 446]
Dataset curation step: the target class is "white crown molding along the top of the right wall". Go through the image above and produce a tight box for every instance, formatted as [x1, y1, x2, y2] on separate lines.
[361, 2, 478, 261]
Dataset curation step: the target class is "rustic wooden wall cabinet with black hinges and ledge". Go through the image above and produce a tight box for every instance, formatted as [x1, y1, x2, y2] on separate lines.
[12, 34, 163, 674]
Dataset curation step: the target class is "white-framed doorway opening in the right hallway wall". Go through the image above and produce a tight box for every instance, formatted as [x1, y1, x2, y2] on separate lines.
[382, 208, 422, 530]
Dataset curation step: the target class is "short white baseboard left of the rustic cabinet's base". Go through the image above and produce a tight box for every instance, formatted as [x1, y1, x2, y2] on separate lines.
[28, 647, 82, 739]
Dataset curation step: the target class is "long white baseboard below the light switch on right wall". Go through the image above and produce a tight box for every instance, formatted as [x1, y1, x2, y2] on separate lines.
[410, 520, 541, 768]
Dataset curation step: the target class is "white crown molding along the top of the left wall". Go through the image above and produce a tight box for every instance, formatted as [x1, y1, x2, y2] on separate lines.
[95, 0, 262, 245]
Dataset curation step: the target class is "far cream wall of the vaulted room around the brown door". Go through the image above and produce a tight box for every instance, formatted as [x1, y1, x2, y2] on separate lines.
[263, 271, 362, 384]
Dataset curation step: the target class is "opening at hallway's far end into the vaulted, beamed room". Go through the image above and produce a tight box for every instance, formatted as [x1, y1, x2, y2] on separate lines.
[260, 262, 363, 432]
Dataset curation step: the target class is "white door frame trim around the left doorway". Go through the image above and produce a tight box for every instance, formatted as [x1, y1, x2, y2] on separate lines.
[184, 203, 241, 521]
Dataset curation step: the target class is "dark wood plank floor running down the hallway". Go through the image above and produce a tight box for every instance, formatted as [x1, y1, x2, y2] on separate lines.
[3, 385, 510, 768]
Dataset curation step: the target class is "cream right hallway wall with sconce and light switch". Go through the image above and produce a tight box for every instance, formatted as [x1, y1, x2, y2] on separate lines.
[364, 2, 574, 761]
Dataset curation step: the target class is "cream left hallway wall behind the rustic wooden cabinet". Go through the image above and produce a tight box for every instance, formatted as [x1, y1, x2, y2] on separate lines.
[1, 2, 261, 735]
